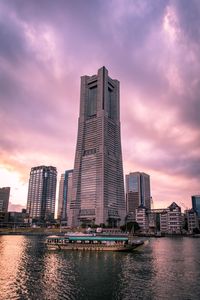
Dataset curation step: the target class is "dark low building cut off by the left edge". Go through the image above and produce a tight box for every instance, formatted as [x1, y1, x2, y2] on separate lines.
[0, 187, 10, 223]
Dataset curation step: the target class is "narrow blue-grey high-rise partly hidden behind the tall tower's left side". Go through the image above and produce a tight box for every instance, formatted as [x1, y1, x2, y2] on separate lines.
[57, 170, 73, 221]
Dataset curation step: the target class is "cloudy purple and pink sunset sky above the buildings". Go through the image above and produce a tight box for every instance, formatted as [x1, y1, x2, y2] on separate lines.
[0, 0, 200, 210]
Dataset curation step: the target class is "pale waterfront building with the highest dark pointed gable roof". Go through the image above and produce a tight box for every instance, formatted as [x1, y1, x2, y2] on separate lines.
[160, 202, 183, 234]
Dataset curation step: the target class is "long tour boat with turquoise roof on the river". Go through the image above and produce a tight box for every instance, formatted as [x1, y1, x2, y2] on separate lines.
[45, 235, 144, 252]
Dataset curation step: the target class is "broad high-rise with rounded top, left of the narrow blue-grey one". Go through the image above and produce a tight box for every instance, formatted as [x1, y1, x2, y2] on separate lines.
[27, 166, 57, 221]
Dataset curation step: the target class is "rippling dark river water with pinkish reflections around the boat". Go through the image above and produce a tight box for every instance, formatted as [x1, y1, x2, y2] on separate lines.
[0, 236, 200, 300]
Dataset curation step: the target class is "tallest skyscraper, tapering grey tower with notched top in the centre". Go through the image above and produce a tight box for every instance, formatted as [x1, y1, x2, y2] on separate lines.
[69, 67, 125, 226]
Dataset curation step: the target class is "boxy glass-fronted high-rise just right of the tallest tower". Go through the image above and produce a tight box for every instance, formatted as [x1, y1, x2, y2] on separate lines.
[126, 172, 151, 219]
